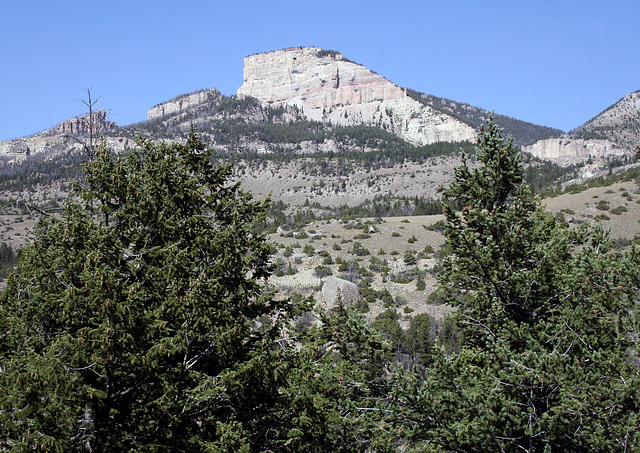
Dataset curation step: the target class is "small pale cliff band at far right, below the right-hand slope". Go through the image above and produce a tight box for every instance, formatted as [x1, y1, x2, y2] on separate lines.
[523, 136, 625, 165]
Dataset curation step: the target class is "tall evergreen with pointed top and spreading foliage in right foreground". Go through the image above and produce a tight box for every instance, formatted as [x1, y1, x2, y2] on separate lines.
[403, 119, 640, 452]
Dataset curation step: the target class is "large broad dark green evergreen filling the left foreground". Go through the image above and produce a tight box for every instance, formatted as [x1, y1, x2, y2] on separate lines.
[0, 131, 298, 452]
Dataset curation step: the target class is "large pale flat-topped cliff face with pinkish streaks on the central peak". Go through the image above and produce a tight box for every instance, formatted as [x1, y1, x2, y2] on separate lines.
[238, 47, 475, 145]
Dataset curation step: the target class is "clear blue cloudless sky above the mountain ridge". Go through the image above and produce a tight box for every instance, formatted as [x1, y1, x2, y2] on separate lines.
[0, 0, 640, 140]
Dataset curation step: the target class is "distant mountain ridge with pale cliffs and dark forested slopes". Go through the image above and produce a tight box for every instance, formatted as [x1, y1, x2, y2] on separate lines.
[0, 47, 640, 204]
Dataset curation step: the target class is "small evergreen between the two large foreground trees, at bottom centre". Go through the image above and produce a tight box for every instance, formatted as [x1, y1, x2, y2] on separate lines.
[274, 309, 401, 453]
